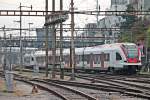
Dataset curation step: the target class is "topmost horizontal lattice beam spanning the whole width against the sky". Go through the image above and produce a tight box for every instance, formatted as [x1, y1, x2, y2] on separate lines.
[0, 10, 150, 17]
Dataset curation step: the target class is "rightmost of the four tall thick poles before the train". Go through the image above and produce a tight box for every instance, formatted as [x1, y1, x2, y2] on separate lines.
[70, 0, 75, 80]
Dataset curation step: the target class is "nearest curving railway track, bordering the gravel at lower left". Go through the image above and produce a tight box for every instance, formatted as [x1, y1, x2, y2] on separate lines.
[14, 74, 97, 100]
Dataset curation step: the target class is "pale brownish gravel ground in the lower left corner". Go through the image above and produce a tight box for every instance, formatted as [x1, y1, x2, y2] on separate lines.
[0, 79, 60, 100]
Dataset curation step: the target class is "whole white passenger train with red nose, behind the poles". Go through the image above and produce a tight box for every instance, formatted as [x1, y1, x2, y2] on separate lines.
[24, 43, 141, 73]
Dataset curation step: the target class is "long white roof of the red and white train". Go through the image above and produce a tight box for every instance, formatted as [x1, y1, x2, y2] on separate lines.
[26, 43, 135, 56]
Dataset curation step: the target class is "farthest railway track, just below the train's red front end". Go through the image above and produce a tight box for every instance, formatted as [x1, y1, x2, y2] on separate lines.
[81, 75, 150, 90]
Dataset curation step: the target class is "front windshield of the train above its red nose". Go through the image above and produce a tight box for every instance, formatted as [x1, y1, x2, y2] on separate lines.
[124, 45, 138, 58]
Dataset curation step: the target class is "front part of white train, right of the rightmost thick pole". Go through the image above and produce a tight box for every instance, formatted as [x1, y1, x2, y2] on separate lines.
[73, 43, 141, 73]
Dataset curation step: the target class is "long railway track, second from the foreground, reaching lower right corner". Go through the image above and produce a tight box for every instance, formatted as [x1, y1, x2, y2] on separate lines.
[10, 71, 150, 99]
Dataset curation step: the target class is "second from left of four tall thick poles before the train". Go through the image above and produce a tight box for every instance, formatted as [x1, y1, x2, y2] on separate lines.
[52, 0, 56, 78]
